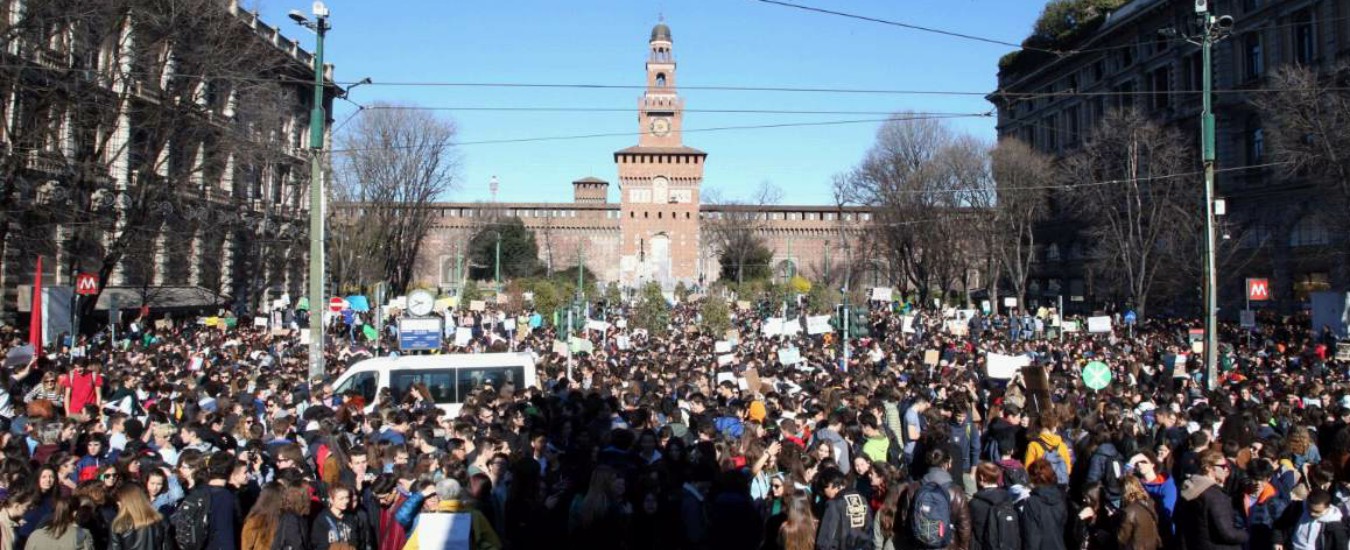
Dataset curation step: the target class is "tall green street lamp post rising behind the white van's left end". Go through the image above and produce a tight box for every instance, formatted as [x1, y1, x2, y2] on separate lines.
[290, 1, 331, 378]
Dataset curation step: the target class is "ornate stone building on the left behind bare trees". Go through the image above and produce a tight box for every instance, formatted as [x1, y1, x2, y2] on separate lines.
[0, 0, 338, 322]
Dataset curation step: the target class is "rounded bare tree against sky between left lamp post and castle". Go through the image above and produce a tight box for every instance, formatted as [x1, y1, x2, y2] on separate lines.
[336, 104, 459, 292]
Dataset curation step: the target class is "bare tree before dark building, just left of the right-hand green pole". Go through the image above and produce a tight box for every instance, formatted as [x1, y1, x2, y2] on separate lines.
[1062, 111, 1202, 316]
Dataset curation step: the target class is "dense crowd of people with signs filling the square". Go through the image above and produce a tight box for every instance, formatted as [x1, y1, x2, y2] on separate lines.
[0, 297, 1350, 550]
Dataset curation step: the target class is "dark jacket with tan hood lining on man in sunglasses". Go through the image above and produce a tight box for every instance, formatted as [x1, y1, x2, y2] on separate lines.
[1175, 474, 1249, 550]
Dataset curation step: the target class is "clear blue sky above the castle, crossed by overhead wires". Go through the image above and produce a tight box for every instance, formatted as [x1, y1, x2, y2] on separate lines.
[257, 0, 1044, 204]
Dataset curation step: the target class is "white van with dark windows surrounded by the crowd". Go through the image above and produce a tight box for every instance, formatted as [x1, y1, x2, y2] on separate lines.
[333, 353, 539, 416]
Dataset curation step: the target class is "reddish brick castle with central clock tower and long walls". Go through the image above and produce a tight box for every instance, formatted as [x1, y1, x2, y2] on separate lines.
[416, 23, 886, 293]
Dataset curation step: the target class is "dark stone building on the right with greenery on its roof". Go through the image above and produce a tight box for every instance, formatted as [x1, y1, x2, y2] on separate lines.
[988, 0, 1350, 316]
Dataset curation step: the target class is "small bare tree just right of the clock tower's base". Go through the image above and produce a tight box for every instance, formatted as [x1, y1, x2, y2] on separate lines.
[703, 181, 783, 284]
